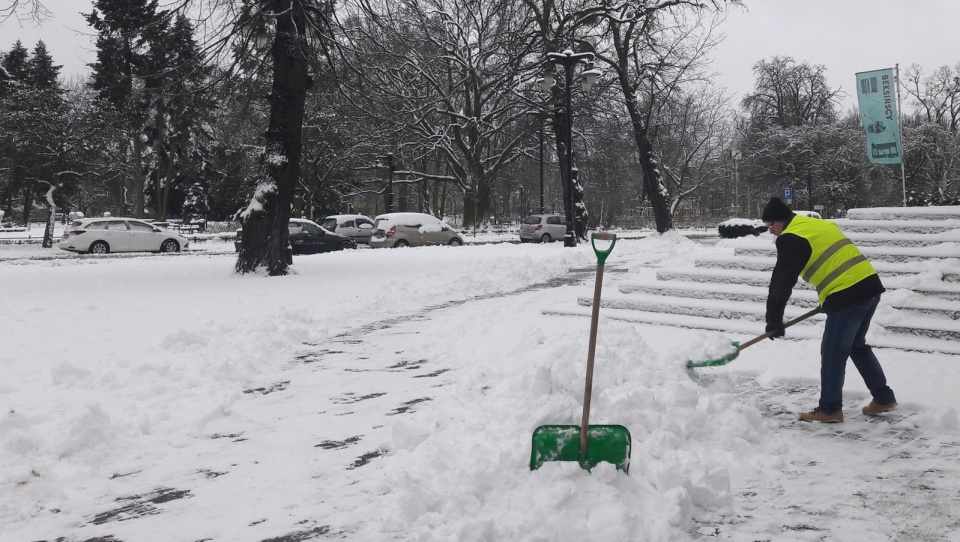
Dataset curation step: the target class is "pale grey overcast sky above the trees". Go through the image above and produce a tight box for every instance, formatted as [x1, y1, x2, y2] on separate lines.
[0, 0, 960, 109]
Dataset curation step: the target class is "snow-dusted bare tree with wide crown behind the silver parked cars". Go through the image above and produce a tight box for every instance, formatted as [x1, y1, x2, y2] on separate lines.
[340, 0, 530, 224]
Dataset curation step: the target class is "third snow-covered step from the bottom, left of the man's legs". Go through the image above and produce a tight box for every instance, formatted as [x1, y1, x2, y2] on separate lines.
[616, 281, 820, 310]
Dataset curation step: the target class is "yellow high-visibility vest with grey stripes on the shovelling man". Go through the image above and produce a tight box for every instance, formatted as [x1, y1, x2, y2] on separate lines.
[783, 215, 877, 305]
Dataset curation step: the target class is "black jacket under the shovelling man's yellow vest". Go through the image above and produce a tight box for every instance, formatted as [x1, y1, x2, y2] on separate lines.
[766, 219, 885, 325]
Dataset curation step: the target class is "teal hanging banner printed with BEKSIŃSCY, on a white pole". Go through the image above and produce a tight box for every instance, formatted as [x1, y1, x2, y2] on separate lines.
[857, 68, 903, 164]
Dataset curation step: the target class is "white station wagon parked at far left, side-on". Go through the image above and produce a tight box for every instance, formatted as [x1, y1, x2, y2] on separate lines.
[59, 217, 190, 254]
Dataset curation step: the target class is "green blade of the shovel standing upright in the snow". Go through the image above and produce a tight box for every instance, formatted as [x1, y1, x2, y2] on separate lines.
[530, 425, 633, 473]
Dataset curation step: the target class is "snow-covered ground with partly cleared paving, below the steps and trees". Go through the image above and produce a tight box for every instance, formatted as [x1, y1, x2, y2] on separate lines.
[0, 232, 960, 542]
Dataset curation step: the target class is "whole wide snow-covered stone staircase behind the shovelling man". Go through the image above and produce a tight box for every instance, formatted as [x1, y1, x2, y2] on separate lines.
[543, 206, 960, 355]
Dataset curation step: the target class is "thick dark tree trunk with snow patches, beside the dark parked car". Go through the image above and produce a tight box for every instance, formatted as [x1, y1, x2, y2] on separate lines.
[236, 0, 310, 276]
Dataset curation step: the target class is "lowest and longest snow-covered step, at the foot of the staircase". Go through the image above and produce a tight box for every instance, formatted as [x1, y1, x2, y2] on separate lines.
[541, 305, 960, 355]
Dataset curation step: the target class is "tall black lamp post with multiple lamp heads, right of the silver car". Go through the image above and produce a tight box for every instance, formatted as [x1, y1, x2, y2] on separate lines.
[543, 49, 600, 247]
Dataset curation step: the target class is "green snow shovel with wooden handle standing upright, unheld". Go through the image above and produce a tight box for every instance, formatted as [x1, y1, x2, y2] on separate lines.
[530, 233, 632, 472]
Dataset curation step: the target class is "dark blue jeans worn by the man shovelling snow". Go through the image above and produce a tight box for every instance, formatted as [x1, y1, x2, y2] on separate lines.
[820, 296, 896, 414]
